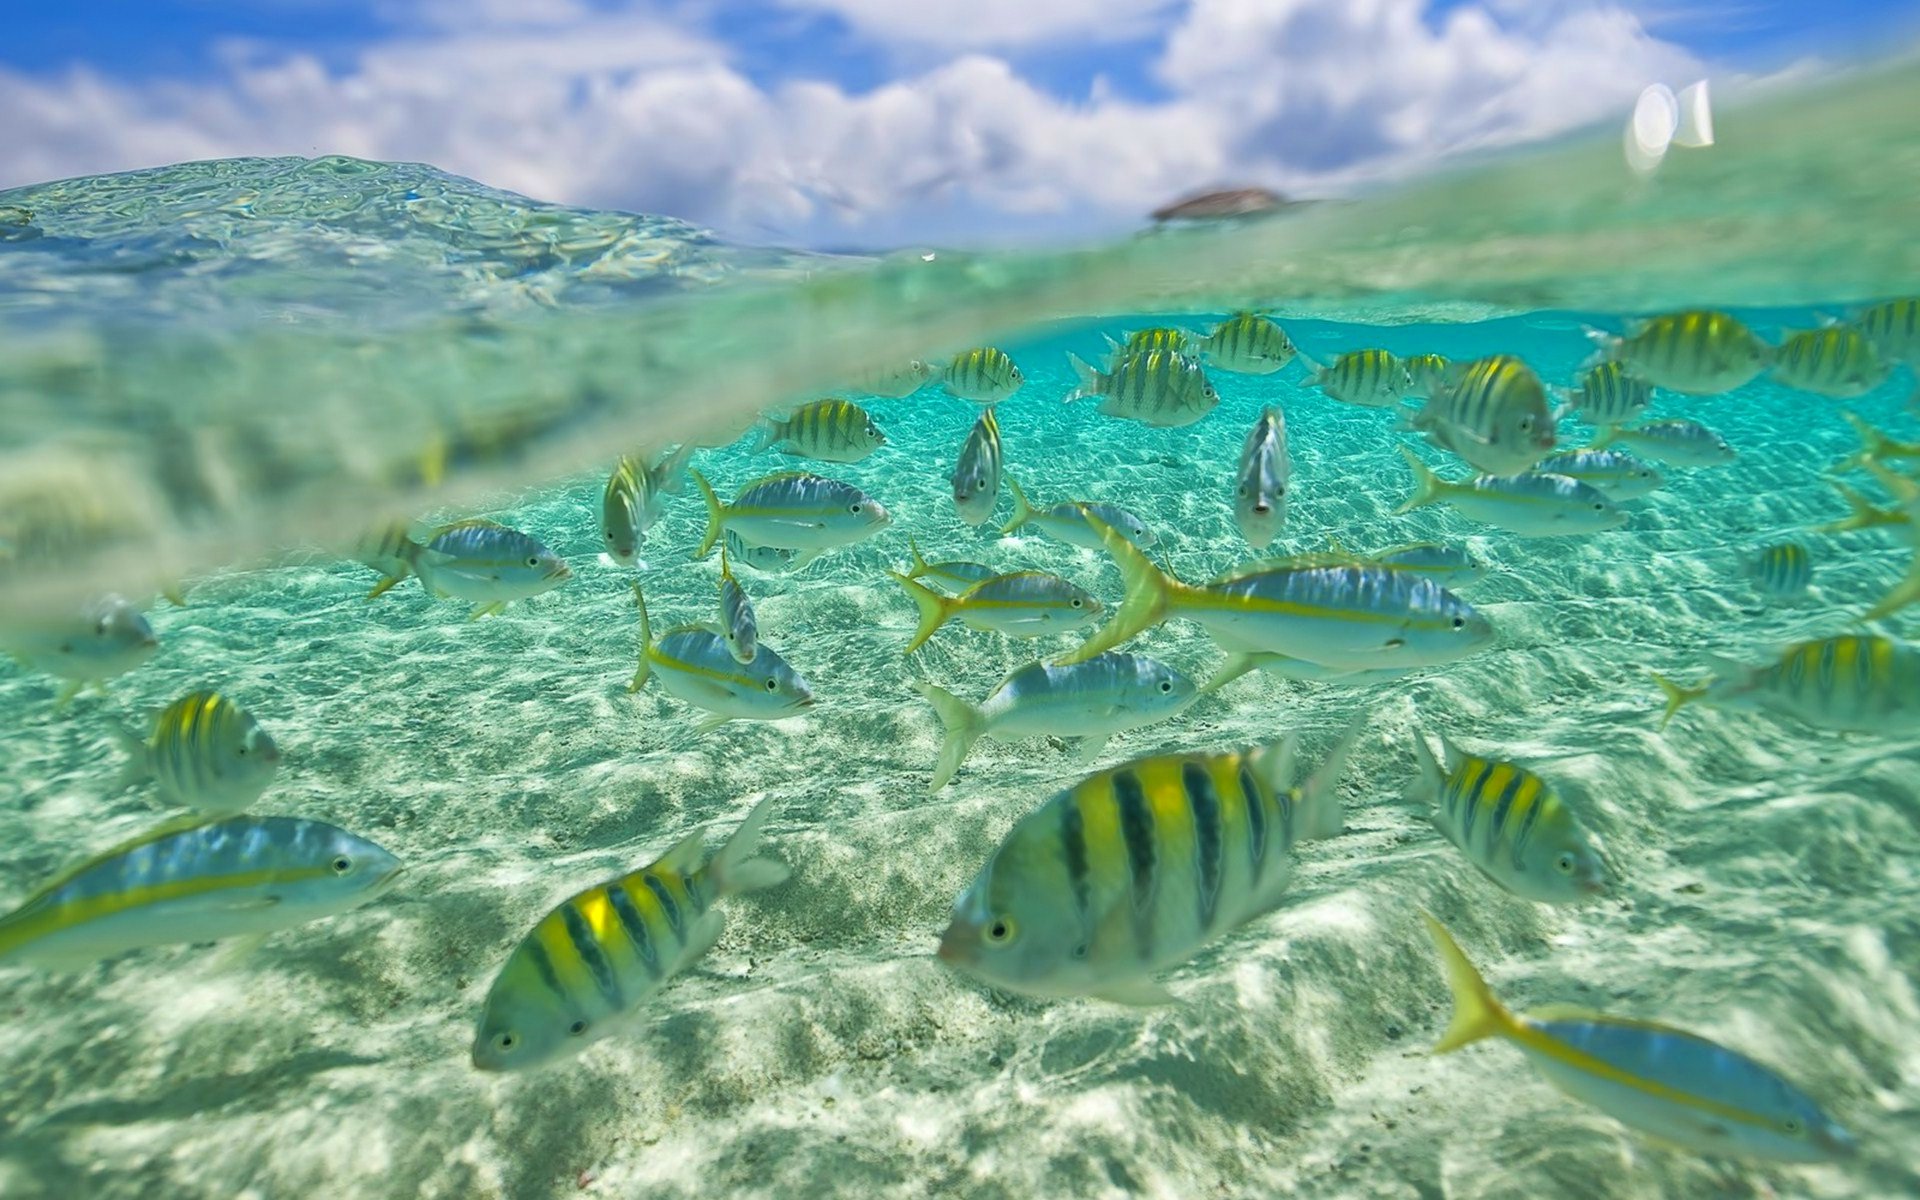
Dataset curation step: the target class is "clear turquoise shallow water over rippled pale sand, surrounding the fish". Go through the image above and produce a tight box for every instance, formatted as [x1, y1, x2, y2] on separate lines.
[0, 60, 1920, 1196]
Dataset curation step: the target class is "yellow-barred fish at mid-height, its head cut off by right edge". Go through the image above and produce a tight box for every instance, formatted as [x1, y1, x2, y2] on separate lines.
[1653, 634, 1920, 733]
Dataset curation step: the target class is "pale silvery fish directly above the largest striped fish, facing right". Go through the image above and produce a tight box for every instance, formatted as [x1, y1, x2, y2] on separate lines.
[914, 651, 1198, 791]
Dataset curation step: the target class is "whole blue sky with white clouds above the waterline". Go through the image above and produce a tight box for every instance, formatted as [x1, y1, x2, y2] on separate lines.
[0, 0, 1920, 248]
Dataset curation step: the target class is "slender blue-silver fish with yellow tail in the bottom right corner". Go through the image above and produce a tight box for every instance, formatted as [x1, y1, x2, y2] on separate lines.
[1423, 914, 1855, 1162]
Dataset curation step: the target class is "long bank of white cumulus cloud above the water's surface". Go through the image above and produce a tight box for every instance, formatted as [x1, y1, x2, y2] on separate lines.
[0, 0, 1697, 244]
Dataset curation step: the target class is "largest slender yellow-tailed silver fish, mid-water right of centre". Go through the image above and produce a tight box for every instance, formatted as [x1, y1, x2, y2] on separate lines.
[1054, 522, 1494, 670]
